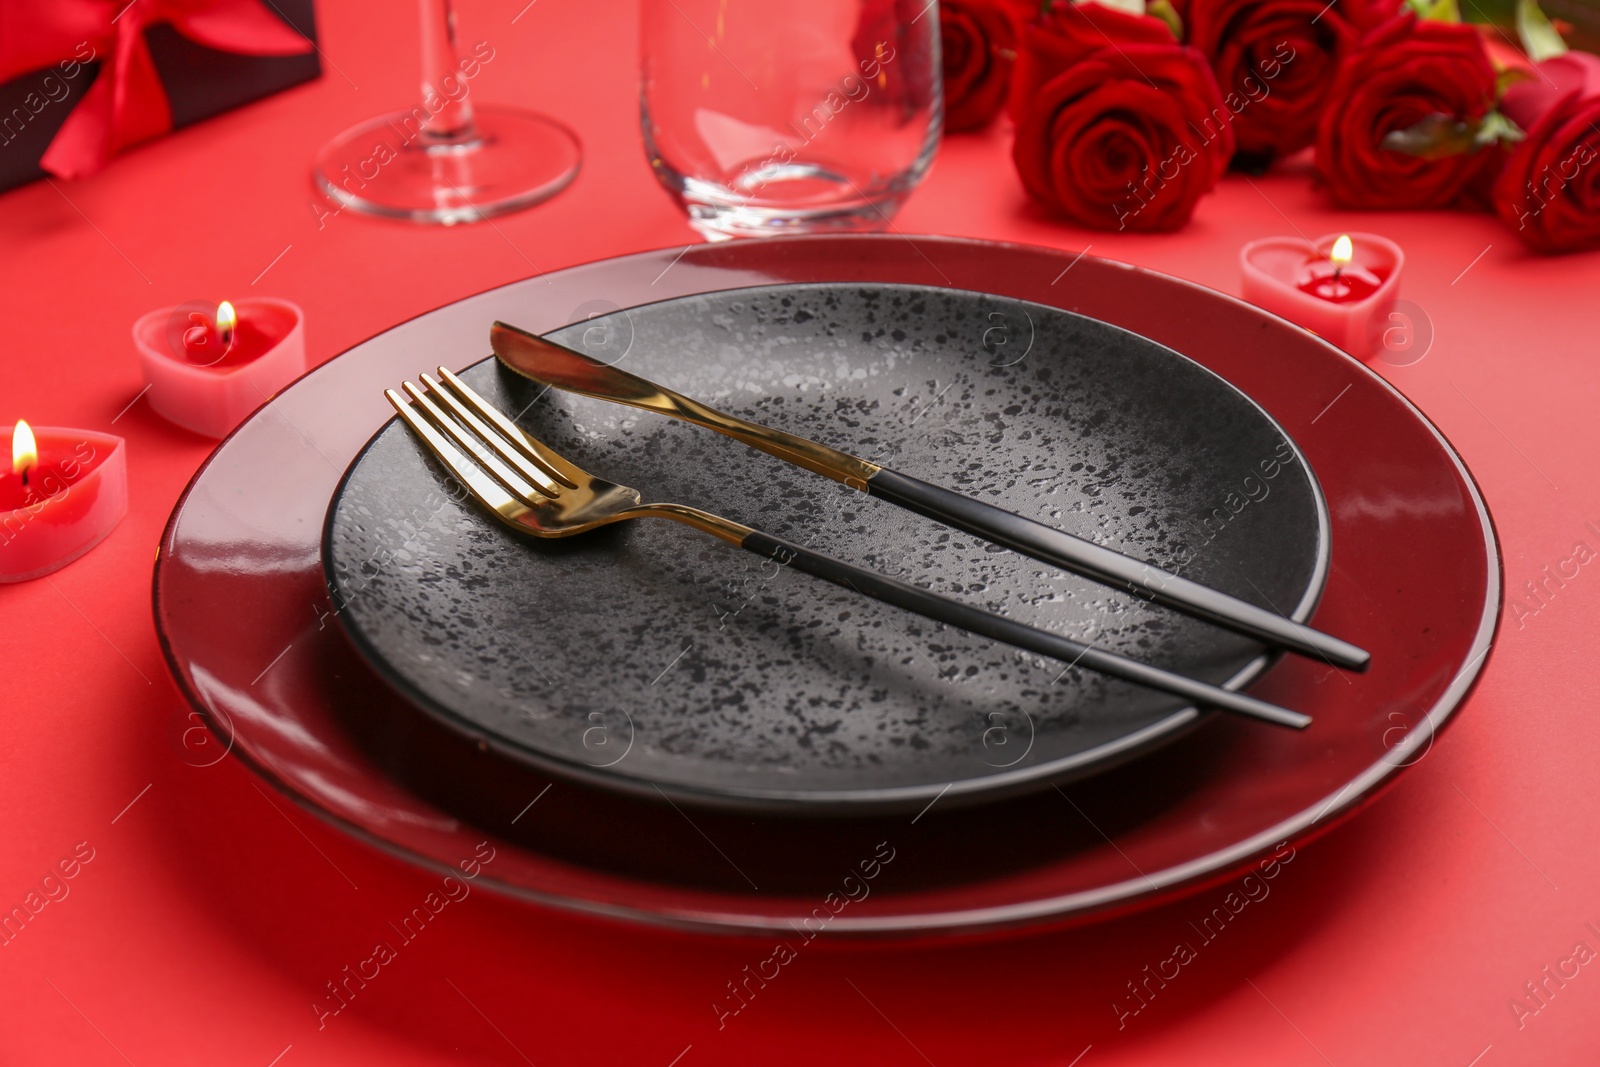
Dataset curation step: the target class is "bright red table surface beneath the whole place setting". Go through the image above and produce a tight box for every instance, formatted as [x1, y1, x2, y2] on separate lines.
[0, 0, 1600, 1067]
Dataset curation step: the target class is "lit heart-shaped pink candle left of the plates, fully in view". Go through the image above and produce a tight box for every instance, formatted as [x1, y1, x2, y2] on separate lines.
[133, 298, 306, 437]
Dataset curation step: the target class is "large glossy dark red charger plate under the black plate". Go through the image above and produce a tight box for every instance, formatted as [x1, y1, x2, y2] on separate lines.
[155, 235, 1501, 934]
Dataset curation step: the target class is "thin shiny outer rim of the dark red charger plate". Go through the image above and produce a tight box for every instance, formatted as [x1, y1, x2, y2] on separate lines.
[150, 232, 1504, 939]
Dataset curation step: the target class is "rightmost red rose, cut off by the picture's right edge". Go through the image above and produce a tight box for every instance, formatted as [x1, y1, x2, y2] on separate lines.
[1494, 51, 1600, 253]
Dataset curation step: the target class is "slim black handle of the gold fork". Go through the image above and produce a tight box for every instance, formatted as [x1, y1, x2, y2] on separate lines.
[739, 530, 1310, 728]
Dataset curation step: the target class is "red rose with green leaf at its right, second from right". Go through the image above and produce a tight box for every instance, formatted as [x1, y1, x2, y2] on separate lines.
[1317, 13, 1494, 208]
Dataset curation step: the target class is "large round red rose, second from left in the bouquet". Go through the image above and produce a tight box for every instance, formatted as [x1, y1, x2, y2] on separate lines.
[1011, 3, 1234, 230]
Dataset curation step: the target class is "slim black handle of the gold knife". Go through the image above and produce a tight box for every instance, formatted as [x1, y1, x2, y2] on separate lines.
[867, 467, 1371, 670]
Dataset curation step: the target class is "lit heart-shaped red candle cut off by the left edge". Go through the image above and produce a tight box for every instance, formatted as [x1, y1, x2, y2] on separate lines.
[0, 427, 128, 582]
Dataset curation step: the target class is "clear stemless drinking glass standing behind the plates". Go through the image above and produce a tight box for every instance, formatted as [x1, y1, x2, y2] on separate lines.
[640, 0, 944, 238]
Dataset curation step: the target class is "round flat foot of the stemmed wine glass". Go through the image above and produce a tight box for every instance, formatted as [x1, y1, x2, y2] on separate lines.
[314, 104, 582, 226]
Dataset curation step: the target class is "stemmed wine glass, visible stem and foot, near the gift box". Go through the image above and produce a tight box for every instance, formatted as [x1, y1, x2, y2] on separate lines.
[314, 0, 582, 226]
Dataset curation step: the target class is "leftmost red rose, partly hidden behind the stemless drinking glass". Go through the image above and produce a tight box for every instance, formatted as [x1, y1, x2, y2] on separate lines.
[939, 0, 1032, 133]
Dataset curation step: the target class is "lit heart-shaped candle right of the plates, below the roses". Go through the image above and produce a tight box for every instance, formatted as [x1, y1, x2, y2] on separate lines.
[1238, 234, 1405, 360]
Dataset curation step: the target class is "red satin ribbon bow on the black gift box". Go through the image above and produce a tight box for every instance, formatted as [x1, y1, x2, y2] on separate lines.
[0, 0, 312, 178]
